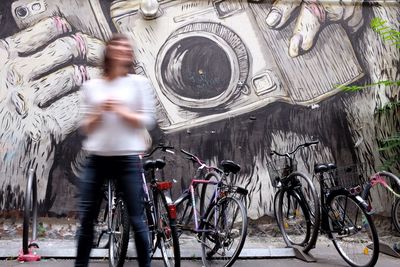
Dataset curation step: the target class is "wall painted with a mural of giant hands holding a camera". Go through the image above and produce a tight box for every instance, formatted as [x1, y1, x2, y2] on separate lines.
[0, 0, 400, 218]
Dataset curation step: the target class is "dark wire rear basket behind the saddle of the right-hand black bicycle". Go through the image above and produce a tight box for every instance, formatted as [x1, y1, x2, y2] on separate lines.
[324, 163, 368, 189]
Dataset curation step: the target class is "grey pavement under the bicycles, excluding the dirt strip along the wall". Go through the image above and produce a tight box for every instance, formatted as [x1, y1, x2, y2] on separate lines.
[0, 236, 400, 267]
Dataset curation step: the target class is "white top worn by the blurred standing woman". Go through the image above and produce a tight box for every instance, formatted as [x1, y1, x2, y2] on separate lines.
[82, 75, 156, 156]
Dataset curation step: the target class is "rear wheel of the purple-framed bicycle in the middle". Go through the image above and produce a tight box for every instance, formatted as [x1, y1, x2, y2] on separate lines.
[201, 196, 248, 267]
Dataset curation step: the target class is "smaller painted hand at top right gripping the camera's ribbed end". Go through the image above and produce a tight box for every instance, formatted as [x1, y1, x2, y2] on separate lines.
[266, 0, 363, 57]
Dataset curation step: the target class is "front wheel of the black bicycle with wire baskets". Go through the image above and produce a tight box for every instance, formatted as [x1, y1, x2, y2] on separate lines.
[277, 190, 311, 250]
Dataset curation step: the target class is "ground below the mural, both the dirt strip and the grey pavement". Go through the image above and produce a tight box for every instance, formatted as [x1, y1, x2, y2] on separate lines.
[0, 219, 400, 267]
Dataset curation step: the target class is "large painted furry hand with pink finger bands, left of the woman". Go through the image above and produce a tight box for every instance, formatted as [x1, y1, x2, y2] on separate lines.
[0, 17, 104, 209]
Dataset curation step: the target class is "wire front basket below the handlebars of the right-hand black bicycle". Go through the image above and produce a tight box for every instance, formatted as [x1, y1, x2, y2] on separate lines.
[267, 158, 297, 187]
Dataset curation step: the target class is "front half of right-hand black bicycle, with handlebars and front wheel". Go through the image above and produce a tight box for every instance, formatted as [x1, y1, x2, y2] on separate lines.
[267, 141, 320, 253]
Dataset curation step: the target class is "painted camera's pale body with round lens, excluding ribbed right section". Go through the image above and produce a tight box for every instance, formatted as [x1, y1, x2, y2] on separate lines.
[111, 1, 284, 131]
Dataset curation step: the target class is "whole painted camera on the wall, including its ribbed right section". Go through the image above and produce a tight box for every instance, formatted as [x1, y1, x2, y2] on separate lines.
[111, 0, 363, 132]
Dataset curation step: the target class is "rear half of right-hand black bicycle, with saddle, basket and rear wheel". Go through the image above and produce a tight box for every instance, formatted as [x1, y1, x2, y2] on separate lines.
[314, 163, 379, 267]
